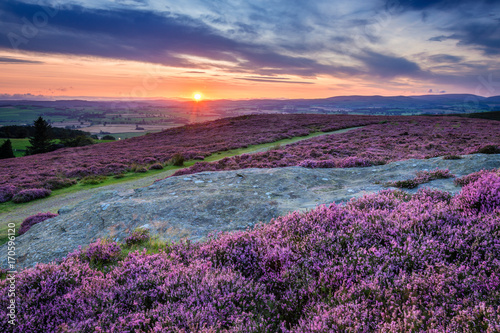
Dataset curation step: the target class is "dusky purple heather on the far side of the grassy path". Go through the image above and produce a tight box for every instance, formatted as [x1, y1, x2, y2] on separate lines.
[0, 114, 378, 199]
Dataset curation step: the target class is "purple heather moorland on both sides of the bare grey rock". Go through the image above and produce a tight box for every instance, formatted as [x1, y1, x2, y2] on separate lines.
[0, 108, 500, 332]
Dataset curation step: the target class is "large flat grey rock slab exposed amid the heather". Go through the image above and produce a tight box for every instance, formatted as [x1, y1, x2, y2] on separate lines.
[0, 154, 500, 268]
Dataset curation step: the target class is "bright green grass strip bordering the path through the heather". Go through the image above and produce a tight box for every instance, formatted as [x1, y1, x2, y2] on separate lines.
[0, 127, 359, 244]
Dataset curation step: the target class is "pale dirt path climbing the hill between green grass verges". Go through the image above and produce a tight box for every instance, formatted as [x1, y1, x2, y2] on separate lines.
[0, 127, 361, 225]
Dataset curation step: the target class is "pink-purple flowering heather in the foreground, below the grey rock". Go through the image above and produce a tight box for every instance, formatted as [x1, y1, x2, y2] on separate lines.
[0, 170, 500, 333]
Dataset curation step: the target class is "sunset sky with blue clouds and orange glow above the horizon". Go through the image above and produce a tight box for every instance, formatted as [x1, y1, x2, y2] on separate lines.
[0, 0, 500, 99]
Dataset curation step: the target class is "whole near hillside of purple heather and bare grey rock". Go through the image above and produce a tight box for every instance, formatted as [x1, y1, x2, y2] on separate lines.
[0, 115, 500, 333]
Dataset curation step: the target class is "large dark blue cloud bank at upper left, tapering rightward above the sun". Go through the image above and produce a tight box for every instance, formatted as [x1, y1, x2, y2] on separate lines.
[0, 0, 360, 76]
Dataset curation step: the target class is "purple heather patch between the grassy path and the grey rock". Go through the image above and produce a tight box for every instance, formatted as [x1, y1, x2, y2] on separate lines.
[174, 117, 500, 176]
